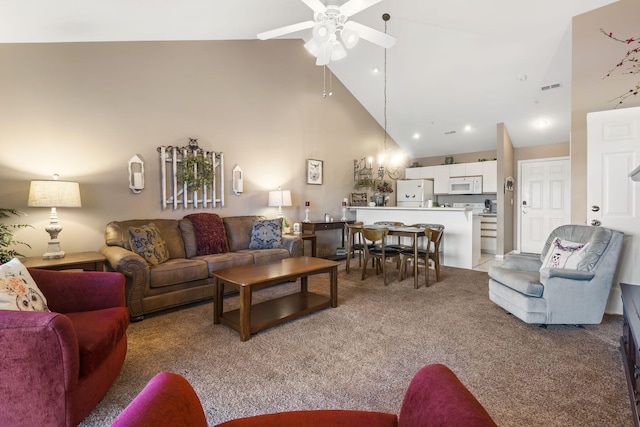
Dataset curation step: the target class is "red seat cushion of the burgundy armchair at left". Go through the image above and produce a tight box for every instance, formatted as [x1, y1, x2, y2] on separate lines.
[65, 307, 129, 377]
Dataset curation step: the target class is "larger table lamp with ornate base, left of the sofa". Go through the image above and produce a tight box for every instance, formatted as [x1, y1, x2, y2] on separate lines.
[27, 174, 82, 259]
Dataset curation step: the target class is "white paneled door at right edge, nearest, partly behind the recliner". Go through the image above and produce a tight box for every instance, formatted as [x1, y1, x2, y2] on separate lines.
[587, 107, 640, 313]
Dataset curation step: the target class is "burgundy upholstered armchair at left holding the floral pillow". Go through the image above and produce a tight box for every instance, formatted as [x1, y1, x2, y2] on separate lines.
[0, 269, 129, 427]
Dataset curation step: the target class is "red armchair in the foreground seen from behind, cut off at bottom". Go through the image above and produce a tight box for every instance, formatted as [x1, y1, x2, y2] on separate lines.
[111, 364, 497, 427]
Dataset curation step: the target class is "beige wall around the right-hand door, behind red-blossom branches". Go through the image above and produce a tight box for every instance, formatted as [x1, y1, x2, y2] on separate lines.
[571, 0, 640, 224]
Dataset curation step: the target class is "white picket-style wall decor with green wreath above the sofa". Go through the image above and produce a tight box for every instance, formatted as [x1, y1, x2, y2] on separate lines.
[158, 138, 224, 209]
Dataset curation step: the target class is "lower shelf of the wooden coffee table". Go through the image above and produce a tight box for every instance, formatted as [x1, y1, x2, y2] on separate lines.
[220, 292, 331, 334]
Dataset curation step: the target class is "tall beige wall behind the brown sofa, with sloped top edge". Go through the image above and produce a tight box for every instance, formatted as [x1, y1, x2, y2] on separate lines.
[0, 40, 395, 255]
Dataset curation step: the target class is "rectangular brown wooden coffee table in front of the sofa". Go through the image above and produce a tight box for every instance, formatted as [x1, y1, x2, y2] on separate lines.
[213, 257, 339, 341]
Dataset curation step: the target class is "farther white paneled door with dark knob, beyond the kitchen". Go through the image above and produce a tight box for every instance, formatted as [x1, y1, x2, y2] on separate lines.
[518, 158, 571, 253]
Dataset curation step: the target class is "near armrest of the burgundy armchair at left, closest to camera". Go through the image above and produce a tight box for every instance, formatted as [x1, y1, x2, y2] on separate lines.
[0, 310, 80, 426]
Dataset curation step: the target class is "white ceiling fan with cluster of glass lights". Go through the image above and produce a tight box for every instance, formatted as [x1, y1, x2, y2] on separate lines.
[258, 0, 396, 65]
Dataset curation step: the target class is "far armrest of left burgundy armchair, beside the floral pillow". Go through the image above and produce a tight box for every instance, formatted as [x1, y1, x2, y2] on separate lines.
[29, 269, 126, 313]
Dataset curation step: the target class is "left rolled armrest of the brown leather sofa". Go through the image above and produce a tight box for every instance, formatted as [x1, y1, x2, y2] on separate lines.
[100, 245, 151, 320]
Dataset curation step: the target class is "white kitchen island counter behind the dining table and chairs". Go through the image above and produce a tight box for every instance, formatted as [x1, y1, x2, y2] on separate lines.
[349, 206, 480, 269]
